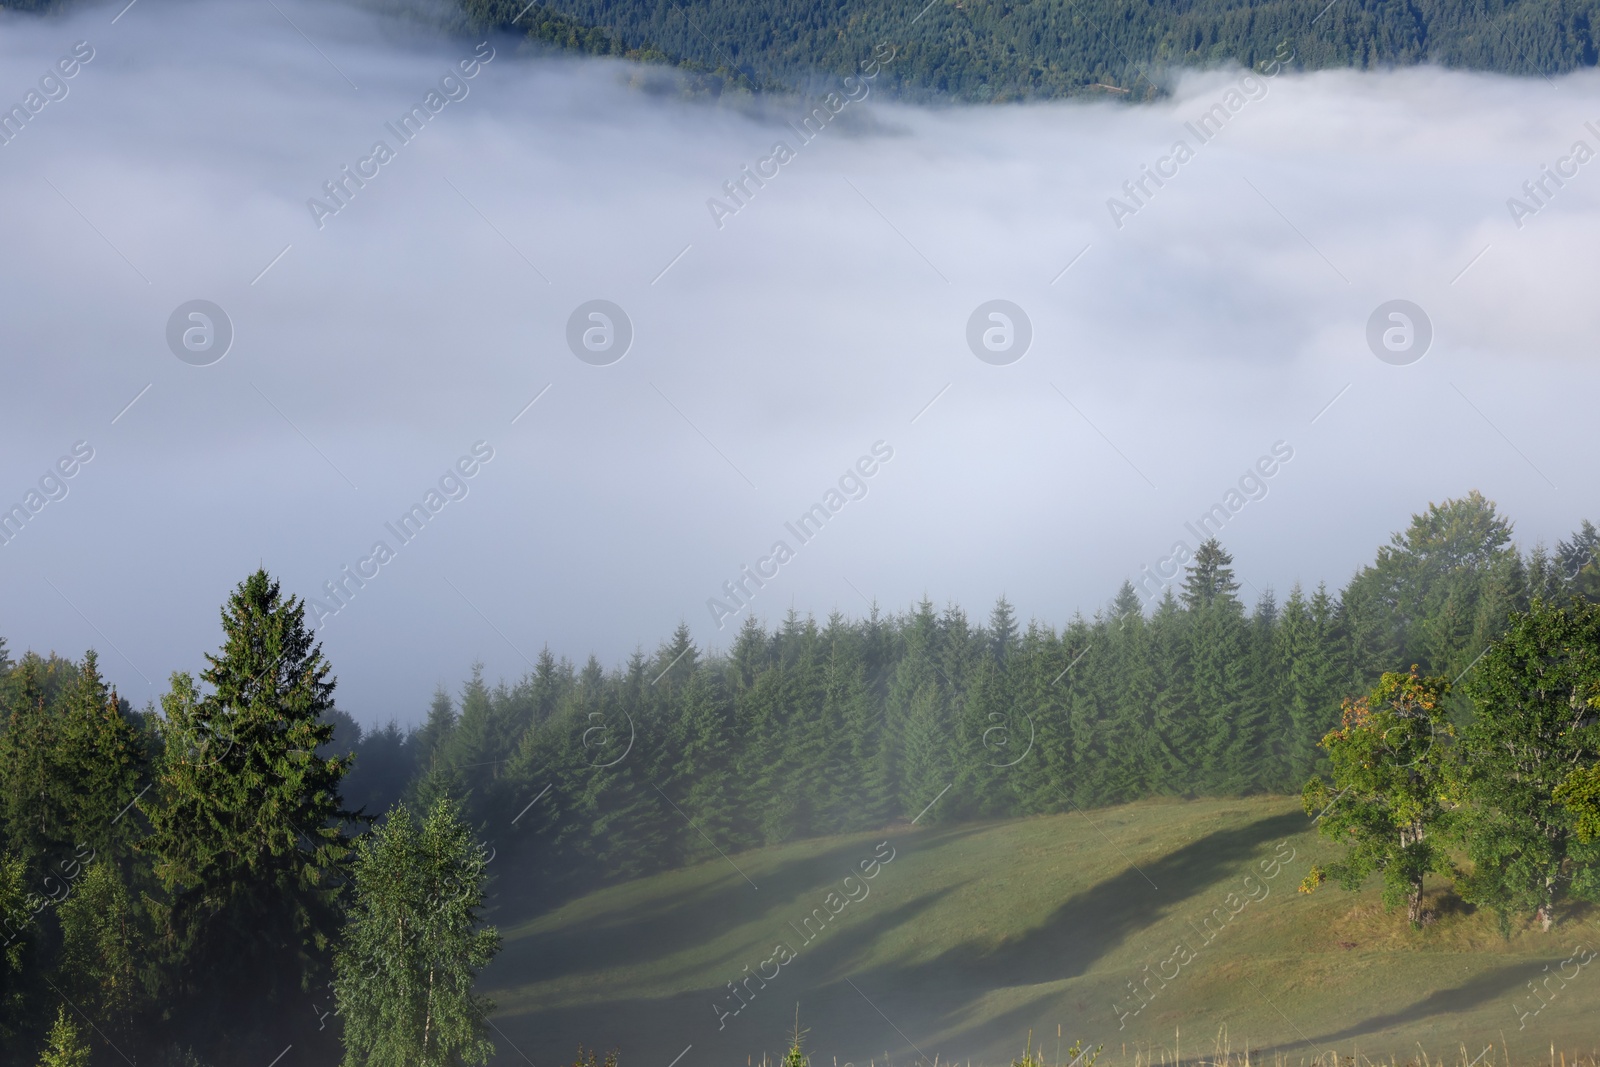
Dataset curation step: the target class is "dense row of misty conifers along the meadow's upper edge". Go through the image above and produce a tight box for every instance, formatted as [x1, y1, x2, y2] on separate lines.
[321, 493, 1600, 877]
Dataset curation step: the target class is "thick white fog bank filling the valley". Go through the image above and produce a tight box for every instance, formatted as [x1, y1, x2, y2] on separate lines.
[0, 0, 1600, 721]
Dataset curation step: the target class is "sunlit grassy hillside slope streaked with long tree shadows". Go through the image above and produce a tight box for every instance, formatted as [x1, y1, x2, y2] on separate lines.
[483, 797, 1600, 1067]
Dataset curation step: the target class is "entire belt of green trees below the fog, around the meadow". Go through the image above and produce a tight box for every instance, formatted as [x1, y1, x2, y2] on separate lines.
[0, 493, 1600, 1064]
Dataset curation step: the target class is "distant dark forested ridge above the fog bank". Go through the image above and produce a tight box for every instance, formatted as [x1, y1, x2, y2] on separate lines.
[461, 0, 1600, 101]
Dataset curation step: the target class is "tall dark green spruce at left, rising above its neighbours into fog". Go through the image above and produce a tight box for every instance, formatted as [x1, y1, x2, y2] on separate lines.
[141, 571, 350, 1024]
